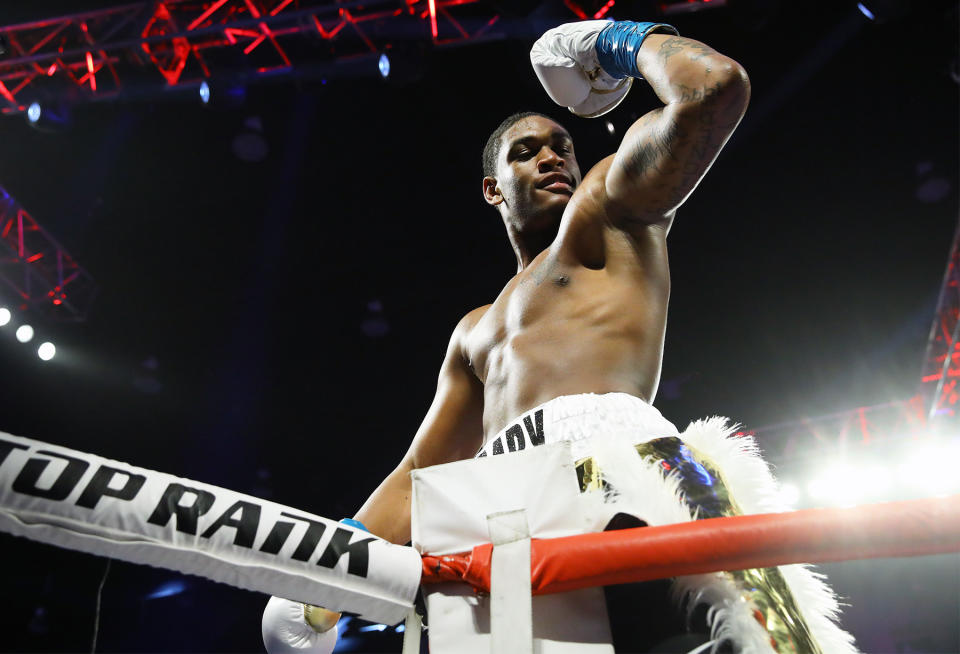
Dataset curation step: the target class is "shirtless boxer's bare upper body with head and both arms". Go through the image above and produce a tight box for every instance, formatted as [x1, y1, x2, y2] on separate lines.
[262, 21, 750, 652]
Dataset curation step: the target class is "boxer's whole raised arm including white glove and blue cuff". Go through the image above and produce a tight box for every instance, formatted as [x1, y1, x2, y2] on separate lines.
[530, 21, 750, 231]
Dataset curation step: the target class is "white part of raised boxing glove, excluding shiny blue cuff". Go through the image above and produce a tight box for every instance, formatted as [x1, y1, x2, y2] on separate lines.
[530, 20, 633, 118]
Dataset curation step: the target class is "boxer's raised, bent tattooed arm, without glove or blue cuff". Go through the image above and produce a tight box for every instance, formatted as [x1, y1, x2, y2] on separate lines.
[601, 34, 750, 225]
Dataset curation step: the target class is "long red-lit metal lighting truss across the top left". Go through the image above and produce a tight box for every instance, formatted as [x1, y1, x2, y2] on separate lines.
[0, 0, 510, 114]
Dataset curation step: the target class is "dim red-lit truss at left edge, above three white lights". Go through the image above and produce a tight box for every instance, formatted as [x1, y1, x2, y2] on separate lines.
[0, 188, 97, 321]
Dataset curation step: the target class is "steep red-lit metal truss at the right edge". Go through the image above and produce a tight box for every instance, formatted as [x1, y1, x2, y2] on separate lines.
[920, 218, 960, 434]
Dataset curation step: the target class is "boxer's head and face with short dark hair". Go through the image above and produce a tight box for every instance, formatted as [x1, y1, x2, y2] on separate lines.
[484, 116, 580, 229]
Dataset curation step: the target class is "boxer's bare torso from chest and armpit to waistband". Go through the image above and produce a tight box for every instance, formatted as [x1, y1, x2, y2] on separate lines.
[461, 189, 670, 442]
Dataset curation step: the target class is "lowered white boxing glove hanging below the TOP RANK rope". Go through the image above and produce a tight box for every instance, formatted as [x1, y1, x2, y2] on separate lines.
[260, 597, 339, 654]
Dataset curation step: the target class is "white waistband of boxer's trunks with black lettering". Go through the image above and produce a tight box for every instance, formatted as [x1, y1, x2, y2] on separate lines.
[476, 393, 679, 459]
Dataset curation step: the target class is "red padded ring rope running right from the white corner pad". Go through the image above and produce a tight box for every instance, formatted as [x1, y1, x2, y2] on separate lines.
[421, 495, 960, 595]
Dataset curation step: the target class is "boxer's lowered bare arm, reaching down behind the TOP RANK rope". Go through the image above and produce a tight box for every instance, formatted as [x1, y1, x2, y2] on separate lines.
[355, 307, 486, 545]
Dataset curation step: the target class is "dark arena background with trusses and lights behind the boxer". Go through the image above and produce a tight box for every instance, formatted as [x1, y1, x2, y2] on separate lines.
[0, 0, 960, 654]
